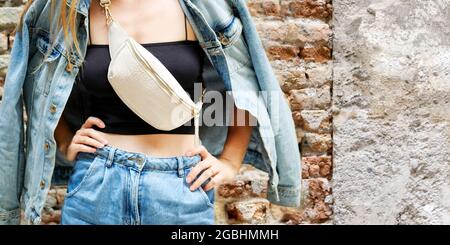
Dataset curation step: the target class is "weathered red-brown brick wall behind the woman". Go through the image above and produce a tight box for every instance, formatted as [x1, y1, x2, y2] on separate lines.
[0, 0, 333, 224]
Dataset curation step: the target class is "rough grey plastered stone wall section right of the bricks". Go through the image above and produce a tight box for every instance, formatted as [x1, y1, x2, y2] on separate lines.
[332, 0, 450, 224]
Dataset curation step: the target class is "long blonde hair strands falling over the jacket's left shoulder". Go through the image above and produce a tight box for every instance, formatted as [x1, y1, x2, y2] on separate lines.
[15, 0, 81, 70]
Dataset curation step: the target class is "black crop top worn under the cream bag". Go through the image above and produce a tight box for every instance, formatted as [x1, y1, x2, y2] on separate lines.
[63, 40, 204, 134]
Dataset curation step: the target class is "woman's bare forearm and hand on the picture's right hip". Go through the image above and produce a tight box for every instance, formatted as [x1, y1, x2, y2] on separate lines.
[186, 106, 253, 191]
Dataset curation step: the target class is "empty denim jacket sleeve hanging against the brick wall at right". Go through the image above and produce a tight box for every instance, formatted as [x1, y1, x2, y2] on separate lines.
[229, 0, 301, 207]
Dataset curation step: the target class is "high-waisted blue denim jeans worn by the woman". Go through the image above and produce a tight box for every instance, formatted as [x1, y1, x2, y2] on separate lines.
[61, 145, 215, 225]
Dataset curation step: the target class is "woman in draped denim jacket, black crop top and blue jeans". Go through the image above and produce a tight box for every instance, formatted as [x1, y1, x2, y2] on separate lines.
[0, 0, 300, 224]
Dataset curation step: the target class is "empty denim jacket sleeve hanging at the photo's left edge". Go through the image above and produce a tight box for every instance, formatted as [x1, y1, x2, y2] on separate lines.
[0, 8, 32, 224]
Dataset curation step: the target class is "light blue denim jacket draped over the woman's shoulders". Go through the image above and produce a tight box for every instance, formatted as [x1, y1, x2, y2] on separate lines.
[0, 0, 301, 224]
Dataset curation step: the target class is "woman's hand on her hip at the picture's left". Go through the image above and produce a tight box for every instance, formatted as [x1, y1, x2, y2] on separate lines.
[66, 117, 108, 161]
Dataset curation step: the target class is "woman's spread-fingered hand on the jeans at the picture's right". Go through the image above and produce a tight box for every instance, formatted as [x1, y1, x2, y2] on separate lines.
[186, 145, 239, 191]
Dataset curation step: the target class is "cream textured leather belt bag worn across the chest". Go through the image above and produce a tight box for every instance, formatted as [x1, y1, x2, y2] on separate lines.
[100, 0, 203, 145]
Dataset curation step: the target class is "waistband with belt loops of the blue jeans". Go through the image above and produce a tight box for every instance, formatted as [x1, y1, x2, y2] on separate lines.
[94, 145, 201, 171]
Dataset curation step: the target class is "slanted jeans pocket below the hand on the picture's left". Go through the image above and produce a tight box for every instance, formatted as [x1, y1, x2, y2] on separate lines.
[66, 152, 101, 198]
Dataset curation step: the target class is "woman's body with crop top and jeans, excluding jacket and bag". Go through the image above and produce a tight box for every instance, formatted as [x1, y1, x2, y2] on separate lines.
[55, 0, 252, 224]
